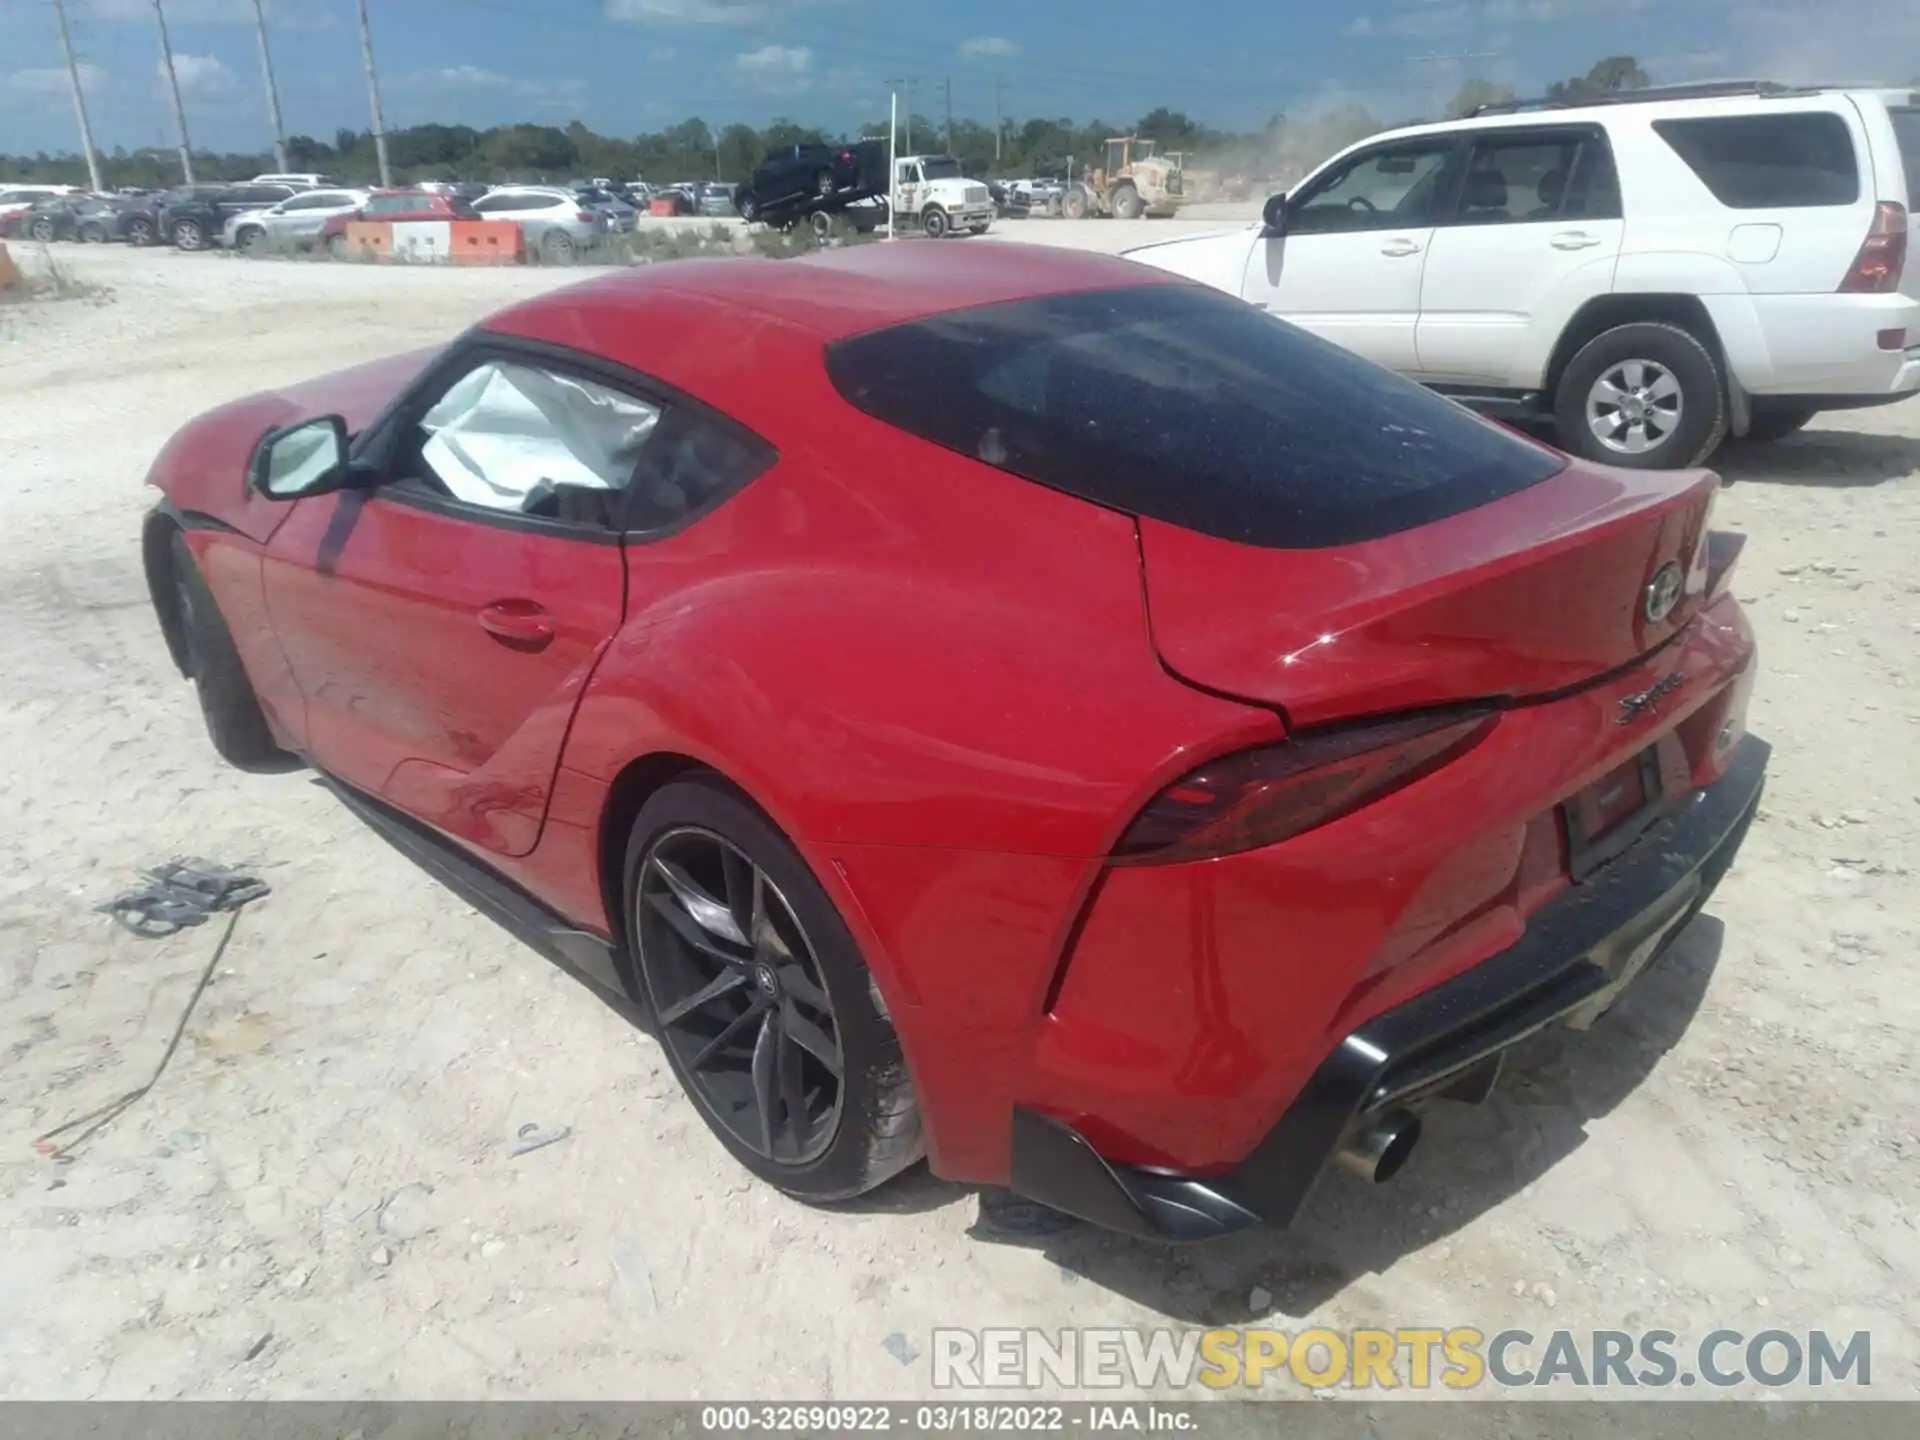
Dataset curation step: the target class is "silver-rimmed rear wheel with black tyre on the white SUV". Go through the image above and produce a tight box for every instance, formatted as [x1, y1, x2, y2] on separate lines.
[1553, 321, 1726, 470]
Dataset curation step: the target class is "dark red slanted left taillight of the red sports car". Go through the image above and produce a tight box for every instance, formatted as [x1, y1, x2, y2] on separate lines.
[1114, 710, 1494, 864]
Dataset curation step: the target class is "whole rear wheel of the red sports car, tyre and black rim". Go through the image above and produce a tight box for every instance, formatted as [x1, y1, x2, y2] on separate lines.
[622, 778, 925, 1202]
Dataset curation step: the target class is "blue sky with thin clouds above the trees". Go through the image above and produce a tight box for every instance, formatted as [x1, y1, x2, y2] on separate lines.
[0, 0, 1920, 154]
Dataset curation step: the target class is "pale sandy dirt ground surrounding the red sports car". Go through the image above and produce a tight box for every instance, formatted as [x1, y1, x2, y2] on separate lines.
[0, 221, 1920, 1398]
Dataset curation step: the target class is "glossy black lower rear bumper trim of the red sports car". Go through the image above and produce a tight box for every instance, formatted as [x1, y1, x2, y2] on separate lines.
[1008, 735, 1770, 1240]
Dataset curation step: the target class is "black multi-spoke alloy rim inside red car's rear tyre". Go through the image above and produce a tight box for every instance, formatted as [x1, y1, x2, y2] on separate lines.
[636, 826, 847, 1167]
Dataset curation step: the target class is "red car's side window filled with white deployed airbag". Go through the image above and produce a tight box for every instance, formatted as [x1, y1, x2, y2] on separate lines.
[417, 361, 660, 526]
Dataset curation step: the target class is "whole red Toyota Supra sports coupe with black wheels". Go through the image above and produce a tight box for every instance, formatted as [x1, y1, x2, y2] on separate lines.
[144, 244, 1766, 1238]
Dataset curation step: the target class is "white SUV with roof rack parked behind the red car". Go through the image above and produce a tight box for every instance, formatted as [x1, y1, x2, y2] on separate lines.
[1129, 83, 1920, 468]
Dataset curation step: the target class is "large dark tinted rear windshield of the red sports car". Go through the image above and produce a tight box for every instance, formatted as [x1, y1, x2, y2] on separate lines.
[828, 284, 1565, 549]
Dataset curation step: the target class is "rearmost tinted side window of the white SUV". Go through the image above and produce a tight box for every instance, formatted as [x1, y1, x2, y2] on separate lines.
[1653, 111, 1860, 209]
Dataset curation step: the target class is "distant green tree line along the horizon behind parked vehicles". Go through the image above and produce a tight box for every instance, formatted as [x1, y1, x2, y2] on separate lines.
[0, 56, 1647, 188]
